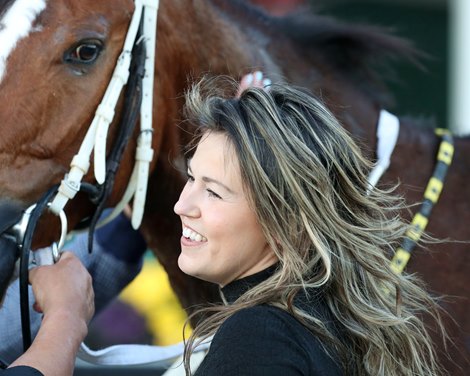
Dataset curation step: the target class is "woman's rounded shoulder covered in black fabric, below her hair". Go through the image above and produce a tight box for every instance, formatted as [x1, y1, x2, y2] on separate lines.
[204, 305, 341, 375]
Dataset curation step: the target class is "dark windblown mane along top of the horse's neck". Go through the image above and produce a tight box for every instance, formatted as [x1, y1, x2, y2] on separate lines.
[211, 0, 422, 104]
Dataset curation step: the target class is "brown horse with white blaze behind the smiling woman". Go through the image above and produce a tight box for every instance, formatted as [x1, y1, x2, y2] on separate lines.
[0, 0, 470, 375]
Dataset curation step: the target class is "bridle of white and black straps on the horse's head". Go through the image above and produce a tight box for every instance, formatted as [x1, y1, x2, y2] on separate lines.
[3, 0, 159, 351]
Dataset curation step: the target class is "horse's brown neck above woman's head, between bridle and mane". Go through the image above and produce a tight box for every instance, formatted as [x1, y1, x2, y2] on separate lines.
[157, 0, 380, 151]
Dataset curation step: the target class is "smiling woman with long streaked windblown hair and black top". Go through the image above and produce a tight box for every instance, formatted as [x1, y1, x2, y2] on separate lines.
[175, 78, 440, 376]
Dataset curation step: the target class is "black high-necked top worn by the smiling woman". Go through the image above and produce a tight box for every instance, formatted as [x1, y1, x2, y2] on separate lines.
[195, 266, 343, 376]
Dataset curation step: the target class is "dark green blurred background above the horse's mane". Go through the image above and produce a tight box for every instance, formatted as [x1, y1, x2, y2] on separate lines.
[255, 0, 450, 127]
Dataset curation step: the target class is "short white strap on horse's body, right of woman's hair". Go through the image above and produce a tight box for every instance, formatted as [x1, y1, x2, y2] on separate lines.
[368, 110, 400, 191]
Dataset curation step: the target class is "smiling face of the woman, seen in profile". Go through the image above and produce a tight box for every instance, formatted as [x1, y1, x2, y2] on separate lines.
[175, 132, 277, 286]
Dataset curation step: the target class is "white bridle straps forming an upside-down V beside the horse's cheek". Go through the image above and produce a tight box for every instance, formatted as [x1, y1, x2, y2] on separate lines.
[49, 0, 159, 228]
